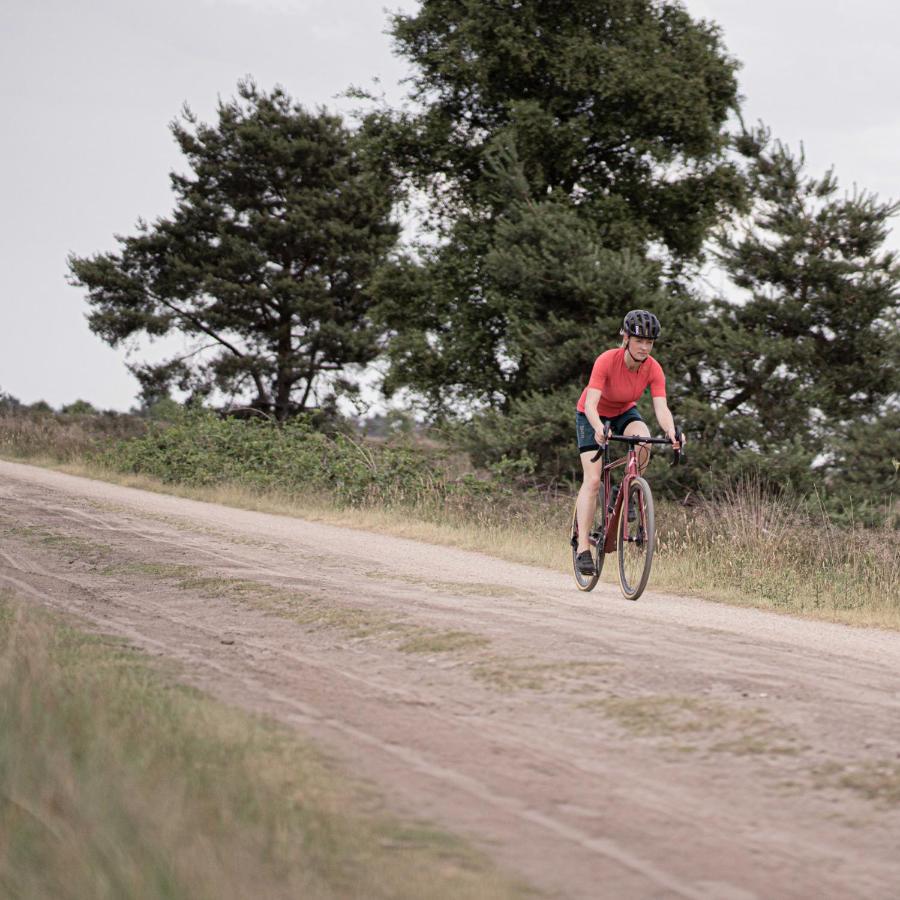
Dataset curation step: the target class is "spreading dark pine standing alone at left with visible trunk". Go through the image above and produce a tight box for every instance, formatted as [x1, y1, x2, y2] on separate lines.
[69, 80, 398, 419]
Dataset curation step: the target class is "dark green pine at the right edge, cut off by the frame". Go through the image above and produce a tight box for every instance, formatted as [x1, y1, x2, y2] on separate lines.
[708, 129, 900, 495]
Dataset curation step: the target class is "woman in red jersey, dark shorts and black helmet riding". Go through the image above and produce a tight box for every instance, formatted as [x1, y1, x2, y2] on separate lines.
[575, 309, 684, 575]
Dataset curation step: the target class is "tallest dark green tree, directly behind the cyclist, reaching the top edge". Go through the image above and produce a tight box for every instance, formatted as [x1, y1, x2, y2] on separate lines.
[369, 0, 743, 474]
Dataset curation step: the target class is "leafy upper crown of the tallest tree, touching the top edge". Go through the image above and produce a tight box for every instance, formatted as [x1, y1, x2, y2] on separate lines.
[389, 0, 737, 255]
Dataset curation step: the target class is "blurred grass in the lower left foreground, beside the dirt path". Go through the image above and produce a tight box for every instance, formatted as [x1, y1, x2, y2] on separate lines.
[0, 595, 533, 900]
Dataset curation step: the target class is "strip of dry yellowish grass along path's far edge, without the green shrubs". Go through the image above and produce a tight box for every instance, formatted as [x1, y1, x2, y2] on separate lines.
[0, 417, 900, 629]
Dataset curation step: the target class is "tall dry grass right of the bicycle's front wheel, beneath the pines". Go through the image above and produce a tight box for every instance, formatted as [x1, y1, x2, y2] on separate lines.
[654, 479, 900, 628]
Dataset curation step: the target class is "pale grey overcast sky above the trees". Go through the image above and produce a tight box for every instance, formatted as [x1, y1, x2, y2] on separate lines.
[0, 0, 900, 410]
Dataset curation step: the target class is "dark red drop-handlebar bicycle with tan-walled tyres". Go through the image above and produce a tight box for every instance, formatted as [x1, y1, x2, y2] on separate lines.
[569, 430, 681, 600]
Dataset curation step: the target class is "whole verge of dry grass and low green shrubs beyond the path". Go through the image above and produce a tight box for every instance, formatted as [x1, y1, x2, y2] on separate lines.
[0, 418, 900, 629]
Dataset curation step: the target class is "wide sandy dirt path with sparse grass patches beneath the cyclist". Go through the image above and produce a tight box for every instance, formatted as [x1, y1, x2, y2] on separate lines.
[0, 462, 900, 898]
